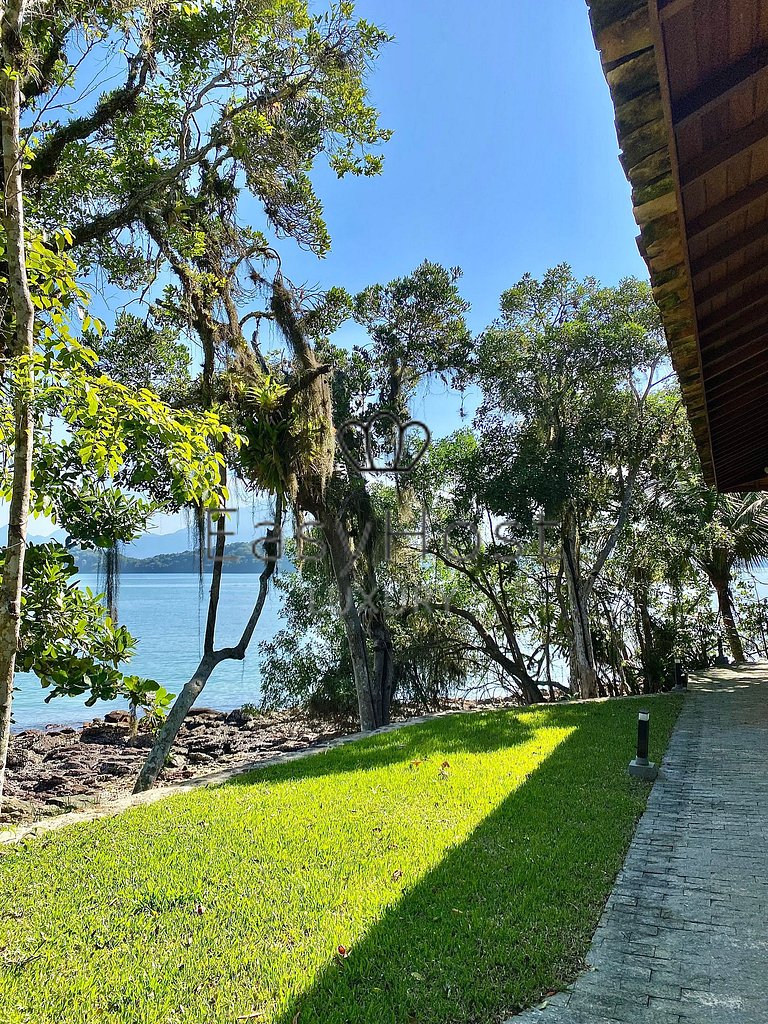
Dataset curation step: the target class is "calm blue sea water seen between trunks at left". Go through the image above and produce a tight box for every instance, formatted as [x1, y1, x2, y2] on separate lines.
[13, 573, 281, 731]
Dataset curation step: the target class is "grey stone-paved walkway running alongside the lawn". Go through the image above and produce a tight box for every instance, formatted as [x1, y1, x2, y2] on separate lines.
[513, 664, 768, 1024]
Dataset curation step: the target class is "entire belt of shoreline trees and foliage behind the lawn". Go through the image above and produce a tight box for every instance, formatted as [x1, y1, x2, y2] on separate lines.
[0, 0, 768, 797]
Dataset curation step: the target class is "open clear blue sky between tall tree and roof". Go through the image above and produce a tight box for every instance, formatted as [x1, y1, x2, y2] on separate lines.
[262, 0, 645, 330]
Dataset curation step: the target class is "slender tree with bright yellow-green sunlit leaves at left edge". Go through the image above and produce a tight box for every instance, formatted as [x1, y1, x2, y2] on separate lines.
[0, 231, 231, 793]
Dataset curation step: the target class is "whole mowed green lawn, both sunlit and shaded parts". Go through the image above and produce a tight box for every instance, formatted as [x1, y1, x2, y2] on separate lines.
[0, 696, 680, 1024]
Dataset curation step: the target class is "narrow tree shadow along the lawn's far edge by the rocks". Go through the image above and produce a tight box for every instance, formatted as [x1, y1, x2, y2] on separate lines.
[225, 710, 548, 785]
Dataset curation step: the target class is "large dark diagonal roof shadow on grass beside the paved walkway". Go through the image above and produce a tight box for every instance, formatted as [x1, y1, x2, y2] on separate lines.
[266, 708, 674, 1024]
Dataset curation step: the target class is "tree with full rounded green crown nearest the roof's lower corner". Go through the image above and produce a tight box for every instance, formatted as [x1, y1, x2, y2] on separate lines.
[479, 265, 665, 696]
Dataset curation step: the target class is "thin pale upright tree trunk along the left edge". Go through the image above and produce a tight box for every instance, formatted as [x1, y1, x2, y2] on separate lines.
[0, 0, 35, 808]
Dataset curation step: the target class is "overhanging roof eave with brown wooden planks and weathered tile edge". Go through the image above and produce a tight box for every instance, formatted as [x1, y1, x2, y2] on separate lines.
[588, 0, 768, 489]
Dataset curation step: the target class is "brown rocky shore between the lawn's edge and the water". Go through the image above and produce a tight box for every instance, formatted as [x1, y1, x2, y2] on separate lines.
[0, 700, 514, 824]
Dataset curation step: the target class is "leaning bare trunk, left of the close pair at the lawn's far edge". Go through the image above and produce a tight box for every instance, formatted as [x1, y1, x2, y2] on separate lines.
[317, 509, 384, 732]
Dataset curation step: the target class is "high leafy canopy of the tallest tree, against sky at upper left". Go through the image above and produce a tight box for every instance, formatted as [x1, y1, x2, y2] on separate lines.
[27, 0, 390, 268]
